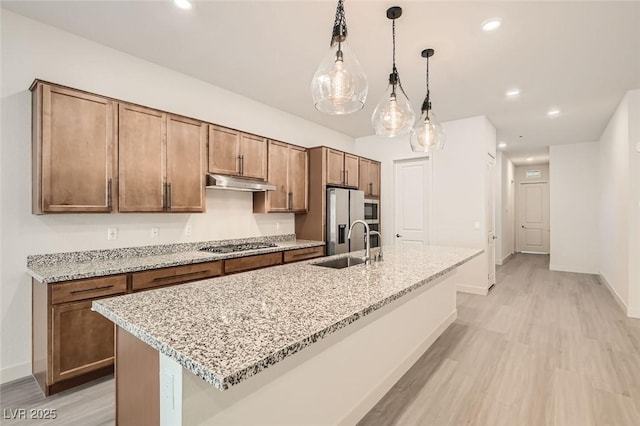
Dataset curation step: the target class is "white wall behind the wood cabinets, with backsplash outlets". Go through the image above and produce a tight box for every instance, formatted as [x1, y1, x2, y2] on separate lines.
[0, 10, 355, 382]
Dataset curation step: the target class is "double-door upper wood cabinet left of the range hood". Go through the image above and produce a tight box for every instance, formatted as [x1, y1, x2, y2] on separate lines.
[118, 104, 206, 212]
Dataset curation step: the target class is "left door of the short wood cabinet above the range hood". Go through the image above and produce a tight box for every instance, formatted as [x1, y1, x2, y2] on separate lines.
[209, 125, 240, 175]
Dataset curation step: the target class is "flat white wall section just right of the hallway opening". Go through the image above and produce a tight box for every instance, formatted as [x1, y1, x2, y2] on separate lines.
[549, 143, 600, 274]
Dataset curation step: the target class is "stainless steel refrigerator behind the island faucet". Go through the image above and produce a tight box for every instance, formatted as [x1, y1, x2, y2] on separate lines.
[327, 188, 364, 255]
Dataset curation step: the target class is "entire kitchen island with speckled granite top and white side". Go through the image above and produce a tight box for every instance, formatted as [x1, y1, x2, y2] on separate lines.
[93, 245, 482, 425]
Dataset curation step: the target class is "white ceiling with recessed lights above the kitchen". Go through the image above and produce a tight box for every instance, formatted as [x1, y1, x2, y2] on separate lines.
[2, 0, 640, 164]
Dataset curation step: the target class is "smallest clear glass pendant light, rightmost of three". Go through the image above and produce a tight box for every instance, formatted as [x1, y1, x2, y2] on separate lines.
[409, 49, 445, 152]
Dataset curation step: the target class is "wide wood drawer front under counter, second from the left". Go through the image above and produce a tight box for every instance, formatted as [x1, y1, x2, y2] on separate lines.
[131, 261, 222, 291]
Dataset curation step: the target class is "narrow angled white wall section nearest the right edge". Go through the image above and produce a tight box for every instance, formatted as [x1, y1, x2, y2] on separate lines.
[599, 95, 637, 307]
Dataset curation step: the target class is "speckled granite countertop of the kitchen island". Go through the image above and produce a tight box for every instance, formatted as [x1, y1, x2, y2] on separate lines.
[93, 246, 482, 390]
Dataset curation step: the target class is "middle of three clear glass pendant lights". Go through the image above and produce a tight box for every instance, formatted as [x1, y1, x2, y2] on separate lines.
[371, 6, 415, 137]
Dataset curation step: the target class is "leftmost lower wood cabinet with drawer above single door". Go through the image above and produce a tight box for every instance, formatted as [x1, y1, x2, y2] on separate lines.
[32, 275, 127, 396]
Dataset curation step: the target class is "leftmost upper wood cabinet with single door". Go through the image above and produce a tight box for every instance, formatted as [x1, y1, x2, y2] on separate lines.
[33, 85, 115, 213]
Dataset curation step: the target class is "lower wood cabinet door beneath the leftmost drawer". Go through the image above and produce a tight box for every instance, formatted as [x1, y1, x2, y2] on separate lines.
[49, 300, 114, 383]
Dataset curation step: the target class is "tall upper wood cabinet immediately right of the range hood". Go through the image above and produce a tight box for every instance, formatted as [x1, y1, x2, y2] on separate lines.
[253, 140, 309, 213]
